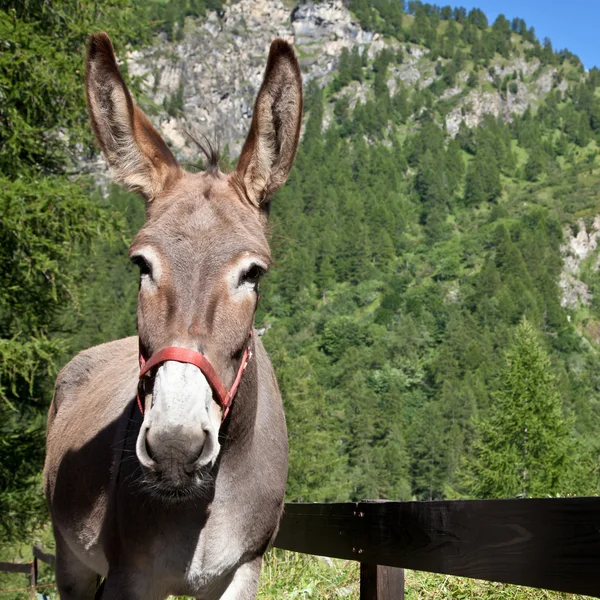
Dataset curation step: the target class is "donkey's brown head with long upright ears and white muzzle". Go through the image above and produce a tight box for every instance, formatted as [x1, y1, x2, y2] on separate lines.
[86, 33, 302, 497]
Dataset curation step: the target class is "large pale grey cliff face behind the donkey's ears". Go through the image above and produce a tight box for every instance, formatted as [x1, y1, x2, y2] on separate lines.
[127, 0, 376, 162]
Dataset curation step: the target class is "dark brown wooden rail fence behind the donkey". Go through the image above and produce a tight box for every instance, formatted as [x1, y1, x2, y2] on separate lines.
[0, 498, 600, 600]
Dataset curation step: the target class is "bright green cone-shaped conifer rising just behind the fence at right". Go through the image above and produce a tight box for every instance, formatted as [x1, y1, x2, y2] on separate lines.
[462, 319, 573, 498]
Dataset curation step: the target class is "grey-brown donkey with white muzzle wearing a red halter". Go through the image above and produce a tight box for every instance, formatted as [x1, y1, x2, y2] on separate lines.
[44, 33, 302, 600]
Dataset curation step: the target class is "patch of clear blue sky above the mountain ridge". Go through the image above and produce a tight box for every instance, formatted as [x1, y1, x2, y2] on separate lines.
[452, 0, 600, 69]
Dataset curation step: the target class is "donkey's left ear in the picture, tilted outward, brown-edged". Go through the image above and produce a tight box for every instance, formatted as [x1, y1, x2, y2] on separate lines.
[85, 33, 181, 201]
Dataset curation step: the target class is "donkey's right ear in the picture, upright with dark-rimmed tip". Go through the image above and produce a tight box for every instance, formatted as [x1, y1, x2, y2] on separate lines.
[236, 39, 302, 205]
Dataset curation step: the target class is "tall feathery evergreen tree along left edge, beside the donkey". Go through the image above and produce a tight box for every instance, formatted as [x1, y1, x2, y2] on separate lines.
[0, 1, 147, 538]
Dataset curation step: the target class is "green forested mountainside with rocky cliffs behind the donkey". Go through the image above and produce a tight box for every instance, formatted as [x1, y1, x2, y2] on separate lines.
[0, 0, 600, 544]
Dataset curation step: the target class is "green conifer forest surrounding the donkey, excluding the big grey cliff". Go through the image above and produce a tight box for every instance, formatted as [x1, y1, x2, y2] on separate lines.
[0, 0, 600, 592]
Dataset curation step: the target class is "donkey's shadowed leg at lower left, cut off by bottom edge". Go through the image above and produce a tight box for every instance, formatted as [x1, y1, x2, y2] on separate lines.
[54, 528, 98, 600]
